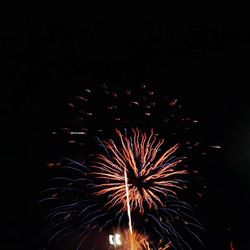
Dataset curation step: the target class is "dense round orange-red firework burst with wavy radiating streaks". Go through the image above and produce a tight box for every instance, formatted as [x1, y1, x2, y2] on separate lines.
[92, 129, 187, 214]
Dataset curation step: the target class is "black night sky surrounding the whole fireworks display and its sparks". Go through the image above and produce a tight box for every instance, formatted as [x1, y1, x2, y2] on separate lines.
[0, 5, 250, 250]
